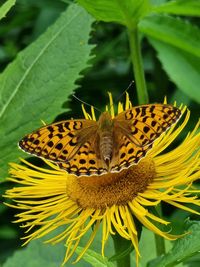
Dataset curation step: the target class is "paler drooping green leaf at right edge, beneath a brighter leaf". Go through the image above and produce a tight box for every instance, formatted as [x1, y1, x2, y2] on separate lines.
[149, 38, 200, 103]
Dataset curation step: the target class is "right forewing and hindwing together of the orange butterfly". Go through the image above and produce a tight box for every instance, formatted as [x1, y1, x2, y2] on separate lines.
[111, 104, 181, 172]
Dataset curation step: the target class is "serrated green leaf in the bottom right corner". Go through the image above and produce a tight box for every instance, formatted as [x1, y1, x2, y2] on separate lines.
[148, 221, 200, 267]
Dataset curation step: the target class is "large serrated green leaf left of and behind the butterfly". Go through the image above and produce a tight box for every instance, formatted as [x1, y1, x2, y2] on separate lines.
[0, 5, 94, 180]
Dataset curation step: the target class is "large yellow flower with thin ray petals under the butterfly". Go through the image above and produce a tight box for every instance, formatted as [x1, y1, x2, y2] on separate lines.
[6, 94, 200, 264]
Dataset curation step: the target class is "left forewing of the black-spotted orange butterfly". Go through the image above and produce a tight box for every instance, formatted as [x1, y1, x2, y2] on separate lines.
[19, 120, 97, 162]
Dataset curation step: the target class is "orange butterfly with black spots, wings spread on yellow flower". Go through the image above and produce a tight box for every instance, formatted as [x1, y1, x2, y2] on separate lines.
[19, 104, 181, 176]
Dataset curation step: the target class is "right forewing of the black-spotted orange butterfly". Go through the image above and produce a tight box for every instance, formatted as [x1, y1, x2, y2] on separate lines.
[115, 104, 181, 147]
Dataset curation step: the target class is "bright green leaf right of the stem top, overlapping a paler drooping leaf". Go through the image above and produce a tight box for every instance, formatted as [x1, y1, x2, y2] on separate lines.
[139, 14, 200, 57]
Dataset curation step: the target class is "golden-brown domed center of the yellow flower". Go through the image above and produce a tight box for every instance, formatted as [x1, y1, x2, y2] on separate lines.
[67, 157, 155, 209]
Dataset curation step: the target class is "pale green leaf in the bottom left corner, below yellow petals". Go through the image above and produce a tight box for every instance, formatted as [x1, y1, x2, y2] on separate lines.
[2, 225, 103, 267]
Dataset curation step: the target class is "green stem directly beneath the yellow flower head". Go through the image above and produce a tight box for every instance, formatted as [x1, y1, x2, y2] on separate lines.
[112, 233, 131, 267]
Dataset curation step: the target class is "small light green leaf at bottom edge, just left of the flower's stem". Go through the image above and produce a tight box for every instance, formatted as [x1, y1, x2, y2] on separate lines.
[76, 246, 115, 267]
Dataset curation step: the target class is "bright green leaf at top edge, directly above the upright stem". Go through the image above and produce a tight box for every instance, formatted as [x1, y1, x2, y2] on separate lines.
[78, 0, 150, 27]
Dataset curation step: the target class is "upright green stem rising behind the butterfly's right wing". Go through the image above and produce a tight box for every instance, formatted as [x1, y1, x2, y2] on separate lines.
[128, 28, 149, 104]
